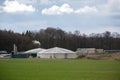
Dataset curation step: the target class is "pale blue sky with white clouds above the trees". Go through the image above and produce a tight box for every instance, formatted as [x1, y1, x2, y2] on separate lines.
[0, 0, 120, 34]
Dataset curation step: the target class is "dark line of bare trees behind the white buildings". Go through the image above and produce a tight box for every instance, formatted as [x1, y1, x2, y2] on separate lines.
[0, 27, 120, 52]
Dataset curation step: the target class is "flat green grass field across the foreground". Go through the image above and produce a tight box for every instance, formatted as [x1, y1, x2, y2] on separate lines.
[0, 59, 120, 80]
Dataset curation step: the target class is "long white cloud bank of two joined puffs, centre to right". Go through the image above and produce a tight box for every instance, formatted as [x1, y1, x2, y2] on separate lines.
[41, 4, 98, 15]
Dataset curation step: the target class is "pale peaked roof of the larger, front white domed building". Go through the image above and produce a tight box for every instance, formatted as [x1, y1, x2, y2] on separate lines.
[39, 47, 75, 54]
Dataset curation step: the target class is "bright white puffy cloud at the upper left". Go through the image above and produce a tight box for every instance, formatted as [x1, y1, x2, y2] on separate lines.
[2, 0, 35, 13]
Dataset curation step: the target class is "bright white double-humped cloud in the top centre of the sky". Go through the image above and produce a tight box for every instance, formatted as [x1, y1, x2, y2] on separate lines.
[41, 4, 73, 15]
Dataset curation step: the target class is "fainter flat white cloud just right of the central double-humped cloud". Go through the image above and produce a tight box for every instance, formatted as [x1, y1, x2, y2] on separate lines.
[75, 6, 98, 14]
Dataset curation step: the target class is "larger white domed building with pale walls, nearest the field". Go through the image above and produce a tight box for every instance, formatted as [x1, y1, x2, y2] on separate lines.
[37, 47, 77, 59]
